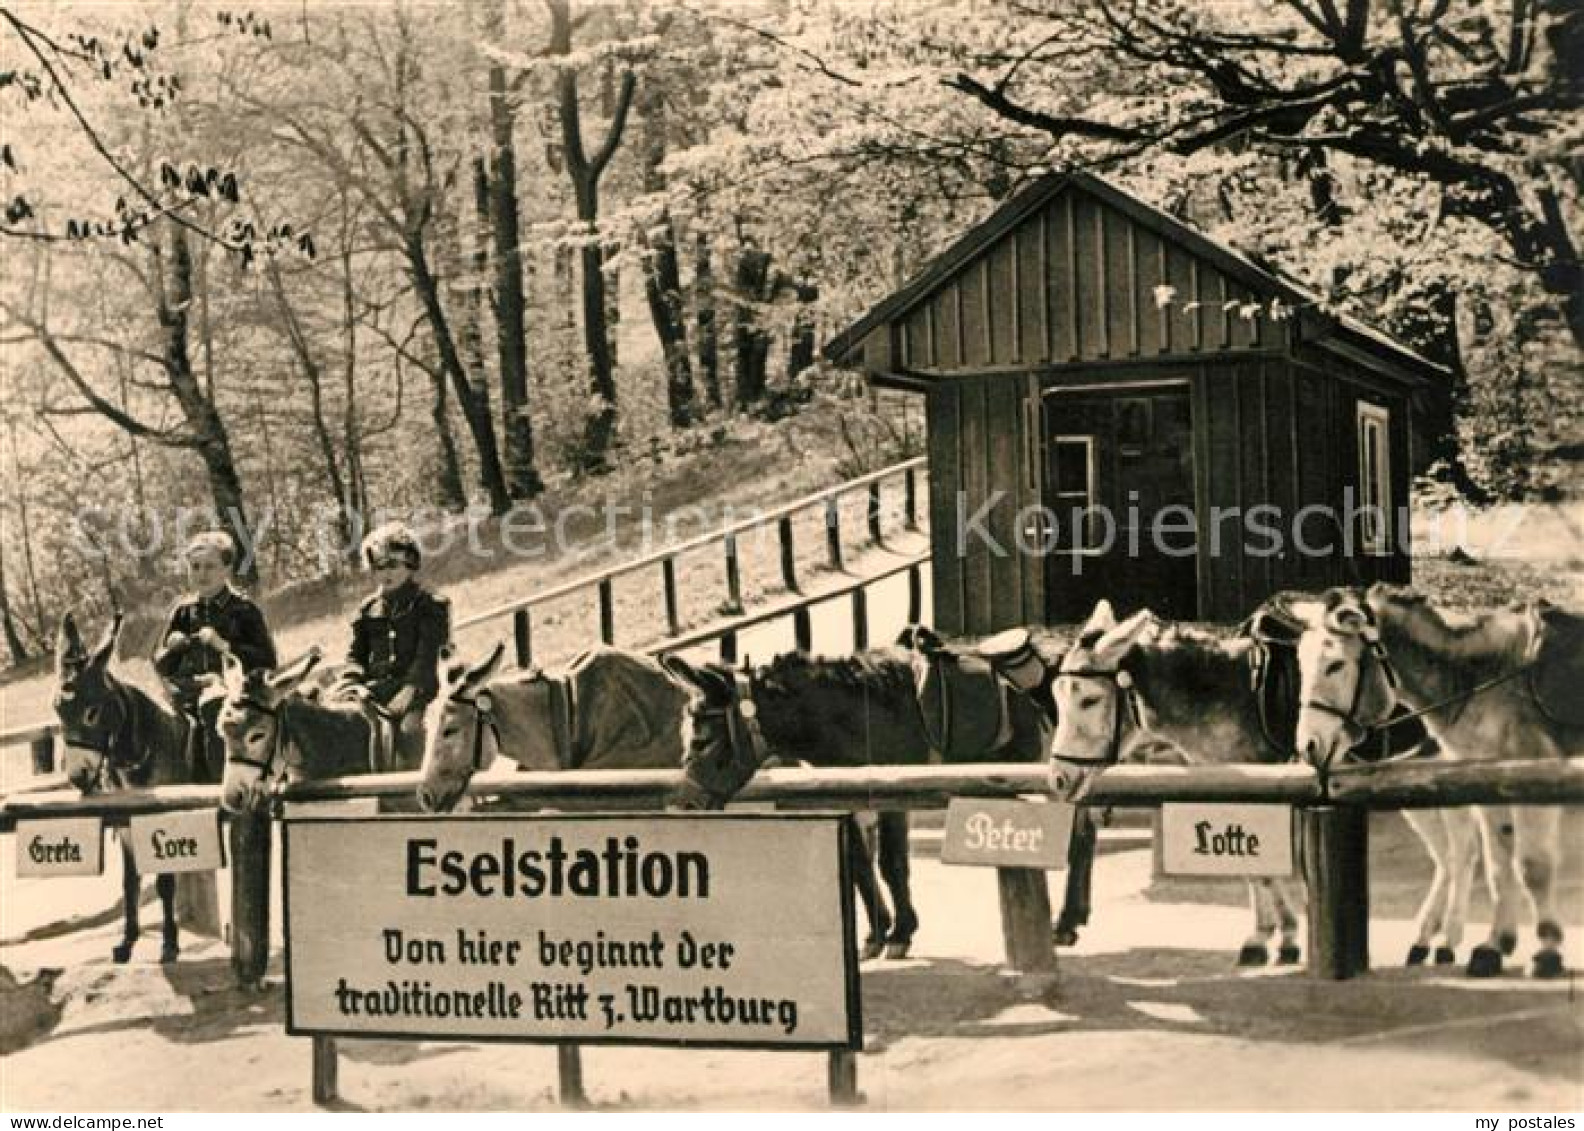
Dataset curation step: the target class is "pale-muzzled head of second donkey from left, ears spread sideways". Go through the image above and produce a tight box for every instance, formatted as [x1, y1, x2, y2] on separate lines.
[217, 648, 322, 813]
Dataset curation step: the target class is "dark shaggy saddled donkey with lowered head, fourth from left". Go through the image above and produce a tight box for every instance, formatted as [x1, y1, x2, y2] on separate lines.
[662, 648, 1050, 958]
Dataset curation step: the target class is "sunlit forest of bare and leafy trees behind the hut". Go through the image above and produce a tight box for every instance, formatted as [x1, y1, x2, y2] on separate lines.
[0, 0, 1584, 659]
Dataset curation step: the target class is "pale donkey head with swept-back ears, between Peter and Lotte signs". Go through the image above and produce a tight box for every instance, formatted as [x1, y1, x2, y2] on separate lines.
[1050, 600, 1159, 792]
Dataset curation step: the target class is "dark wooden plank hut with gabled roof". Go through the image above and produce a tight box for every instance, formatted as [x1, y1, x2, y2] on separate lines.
[825, 173, 1448, 634]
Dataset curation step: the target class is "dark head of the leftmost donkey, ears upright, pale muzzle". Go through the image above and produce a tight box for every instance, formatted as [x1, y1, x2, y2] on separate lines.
[55, 611, 131, 794]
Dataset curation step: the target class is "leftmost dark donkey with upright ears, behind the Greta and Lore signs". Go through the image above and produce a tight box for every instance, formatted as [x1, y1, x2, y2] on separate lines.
[55, 611, 201, 963]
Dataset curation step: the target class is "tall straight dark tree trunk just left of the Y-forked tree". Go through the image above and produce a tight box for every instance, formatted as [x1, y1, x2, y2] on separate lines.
[485, 0, 545, 499]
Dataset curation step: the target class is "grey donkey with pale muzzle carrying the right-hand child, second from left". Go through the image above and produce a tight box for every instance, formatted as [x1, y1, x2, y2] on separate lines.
[219, 648, 402, 813]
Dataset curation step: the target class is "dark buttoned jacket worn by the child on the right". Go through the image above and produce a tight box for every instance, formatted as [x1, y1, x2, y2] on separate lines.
[347, 580, 451, 706]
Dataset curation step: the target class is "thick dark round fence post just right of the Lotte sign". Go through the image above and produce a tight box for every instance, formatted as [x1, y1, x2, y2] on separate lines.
[1297, 805, 1370, 981]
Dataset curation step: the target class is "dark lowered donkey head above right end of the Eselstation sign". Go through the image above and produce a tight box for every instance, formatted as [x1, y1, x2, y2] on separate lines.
[661, 656, 767, 809]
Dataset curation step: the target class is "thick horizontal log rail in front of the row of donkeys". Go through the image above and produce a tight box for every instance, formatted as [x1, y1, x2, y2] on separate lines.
[0, 757, 1584, 832]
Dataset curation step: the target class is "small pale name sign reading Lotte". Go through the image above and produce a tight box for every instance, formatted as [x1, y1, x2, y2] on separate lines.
[1159, 805, 1293, 876]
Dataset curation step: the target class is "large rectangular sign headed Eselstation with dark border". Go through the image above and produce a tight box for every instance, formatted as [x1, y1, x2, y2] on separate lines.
[285, 814, 862, 1049]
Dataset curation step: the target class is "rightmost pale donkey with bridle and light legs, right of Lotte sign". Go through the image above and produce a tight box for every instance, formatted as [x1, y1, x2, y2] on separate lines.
[1296, 585, 1584, 977]
